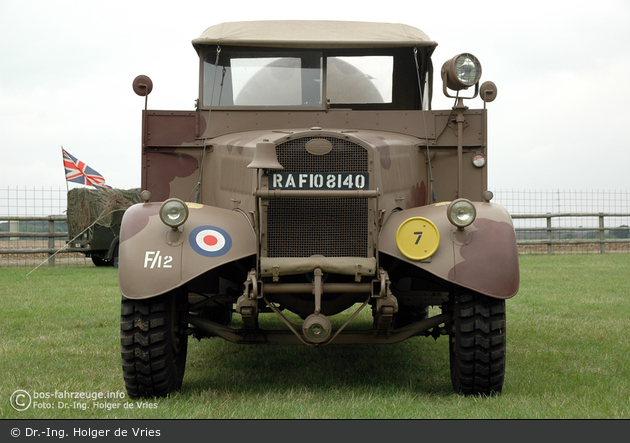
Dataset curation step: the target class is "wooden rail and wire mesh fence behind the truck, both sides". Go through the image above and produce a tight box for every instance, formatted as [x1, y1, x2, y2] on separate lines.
[0, 187, 630, 267]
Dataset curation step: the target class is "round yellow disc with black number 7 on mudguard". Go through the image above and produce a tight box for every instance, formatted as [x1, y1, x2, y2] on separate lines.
[396, 217, 440, 260]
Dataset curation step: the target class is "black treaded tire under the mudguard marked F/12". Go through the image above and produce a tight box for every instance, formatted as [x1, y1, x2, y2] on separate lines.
[120, 290, 188, 398]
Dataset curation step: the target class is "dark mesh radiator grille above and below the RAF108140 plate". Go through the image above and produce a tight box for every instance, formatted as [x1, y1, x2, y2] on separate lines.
[267, 137, 369, 257]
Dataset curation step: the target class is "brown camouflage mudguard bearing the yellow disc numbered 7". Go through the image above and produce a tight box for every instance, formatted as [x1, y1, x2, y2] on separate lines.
[379, 202, 519, 299]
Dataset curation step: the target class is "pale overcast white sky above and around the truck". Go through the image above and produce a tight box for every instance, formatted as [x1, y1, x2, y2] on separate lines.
[0, 0, 630, 190]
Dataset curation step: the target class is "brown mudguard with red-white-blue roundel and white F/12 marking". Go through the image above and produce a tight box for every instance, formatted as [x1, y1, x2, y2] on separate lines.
[118, 203, 257, 299]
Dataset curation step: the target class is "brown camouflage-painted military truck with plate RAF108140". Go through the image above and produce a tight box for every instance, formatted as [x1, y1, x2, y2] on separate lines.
[119, 21, 519, 397]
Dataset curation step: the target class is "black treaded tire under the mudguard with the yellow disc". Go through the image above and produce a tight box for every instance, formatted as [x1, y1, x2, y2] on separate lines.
[450, 293, 506, 395]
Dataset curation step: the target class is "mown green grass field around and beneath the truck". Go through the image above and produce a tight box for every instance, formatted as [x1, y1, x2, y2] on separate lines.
[0, 254, 630, 419]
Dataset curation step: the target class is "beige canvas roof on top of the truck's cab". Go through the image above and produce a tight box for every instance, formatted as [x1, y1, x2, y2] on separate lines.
[192, 20, 437, 48]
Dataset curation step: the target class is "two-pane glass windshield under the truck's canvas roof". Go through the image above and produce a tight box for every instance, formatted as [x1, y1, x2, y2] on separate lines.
[202, 50, 394, 108]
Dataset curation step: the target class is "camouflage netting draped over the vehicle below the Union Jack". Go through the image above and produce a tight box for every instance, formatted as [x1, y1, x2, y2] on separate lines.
[67, 188, 140, 238]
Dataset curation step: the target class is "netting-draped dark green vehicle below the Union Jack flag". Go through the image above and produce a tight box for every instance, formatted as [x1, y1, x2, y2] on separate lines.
[67, 188, 140, 267]
